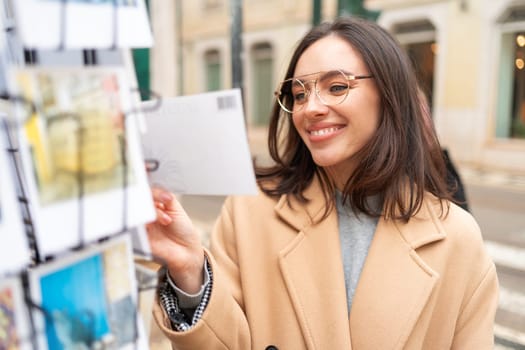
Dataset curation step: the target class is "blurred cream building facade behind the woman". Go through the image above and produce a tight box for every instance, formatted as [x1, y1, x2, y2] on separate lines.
[146, 0, 525, 175]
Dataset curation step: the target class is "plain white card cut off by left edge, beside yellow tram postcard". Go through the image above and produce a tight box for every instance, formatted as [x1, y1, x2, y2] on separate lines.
[0, 117, 31, 276]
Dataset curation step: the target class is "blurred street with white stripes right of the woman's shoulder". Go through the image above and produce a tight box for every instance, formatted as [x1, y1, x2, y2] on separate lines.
[466, 181, 525, 349]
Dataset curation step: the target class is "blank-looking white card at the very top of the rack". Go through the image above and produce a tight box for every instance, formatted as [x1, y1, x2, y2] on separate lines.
[13, 0, 153, 49]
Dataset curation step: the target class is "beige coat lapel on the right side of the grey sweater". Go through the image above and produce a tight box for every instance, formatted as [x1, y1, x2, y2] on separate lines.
[350, 198, 445, 349]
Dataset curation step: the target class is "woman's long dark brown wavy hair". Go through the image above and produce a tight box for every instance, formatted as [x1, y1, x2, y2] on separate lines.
[255, 17, 451, 221]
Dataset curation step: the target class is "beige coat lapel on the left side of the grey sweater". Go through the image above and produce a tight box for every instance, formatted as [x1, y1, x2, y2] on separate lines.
[276, 180, 351, 350]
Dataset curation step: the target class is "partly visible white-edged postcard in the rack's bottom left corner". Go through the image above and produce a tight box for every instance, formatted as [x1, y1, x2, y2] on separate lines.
[0, 276, 33, 350]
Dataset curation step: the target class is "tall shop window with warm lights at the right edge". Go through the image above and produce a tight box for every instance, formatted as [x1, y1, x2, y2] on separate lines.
[496, 7, 525, 139]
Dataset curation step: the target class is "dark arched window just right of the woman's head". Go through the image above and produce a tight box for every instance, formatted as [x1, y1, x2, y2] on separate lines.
[393, 20, 438, 108]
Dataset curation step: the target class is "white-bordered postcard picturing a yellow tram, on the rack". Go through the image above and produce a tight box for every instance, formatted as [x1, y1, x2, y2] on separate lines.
[9, 67, 155, 256]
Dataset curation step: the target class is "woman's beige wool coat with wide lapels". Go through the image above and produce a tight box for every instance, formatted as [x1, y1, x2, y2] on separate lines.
[154, 179, 498, 350]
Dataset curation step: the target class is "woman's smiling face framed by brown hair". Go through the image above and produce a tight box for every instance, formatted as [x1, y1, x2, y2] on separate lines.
[292, 35, 380, 189]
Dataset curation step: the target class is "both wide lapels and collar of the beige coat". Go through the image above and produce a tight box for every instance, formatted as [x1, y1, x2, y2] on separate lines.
[275, 180, 445, 350]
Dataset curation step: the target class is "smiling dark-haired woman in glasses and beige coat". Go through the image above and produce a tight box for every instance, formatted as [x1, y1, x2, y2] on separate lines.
[148, 18, 498, 350]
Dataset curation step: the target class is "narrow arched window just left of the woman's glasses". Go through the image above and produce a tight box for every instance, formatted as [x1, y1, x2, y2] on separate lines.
[251, 43, 275, 126]
